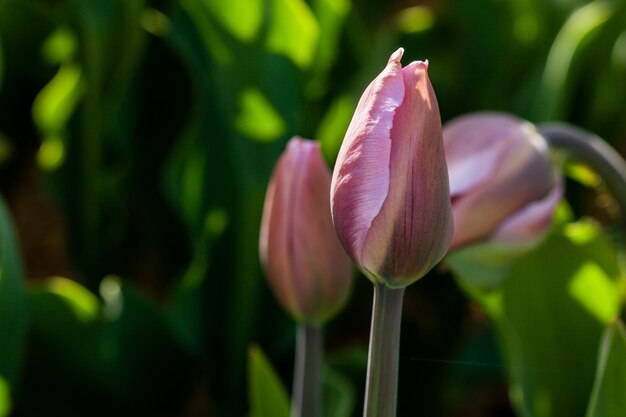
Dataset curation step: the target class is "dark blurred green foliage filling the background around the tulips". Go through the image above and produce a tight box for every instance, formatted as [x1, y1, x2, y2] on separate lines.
[0, 0, 626, 417]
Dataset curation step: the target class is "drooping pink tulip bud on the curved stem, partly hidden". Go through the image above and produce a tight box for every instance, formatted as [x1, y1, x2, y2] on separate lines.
[443, 113, 563, 250]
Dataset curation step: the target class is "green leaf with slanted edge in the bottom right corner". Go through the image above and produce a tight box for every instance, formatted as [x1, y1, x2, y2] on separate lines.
[586, 321, 626, 417]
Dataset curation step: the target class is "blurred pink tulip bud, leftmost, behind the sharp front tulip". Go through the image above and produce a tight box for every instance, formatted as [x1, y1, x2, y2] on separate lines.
[259, 137, 352, 324]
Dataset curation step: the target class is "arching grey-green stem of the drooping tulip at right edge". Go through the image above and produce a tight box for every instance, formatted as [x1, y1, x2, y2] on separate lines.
[537, 122, 626, 223]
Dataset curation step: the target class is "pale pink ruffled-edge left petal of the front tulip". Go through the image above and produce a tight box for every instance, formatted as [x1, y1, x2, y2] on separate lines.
[331, 48, 404, 264]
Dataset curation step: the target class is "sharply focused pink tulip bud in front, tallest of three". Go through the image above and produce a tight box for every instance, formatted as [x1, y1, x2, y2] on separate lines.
[331, 49, 452, 287]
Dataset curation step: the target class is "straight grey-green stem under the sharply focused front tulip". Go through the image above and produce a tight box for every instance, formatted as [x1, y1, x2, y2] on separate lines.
[363, 284, 404, 417]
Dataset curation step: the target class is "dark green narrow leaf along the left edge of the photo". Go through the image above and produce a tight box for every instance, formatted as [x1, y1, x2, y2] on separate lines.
[0, 198, 26, 386]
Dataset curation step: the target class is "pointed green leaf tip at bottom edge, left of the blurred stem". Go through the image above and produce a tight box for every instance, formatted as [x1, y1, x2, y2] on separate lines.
[248, 346, 289, 417]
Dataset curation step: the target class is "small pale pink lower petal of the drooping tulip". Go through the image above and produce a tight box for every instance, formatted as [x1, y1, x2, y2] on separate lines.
[492, 176, 563, 247]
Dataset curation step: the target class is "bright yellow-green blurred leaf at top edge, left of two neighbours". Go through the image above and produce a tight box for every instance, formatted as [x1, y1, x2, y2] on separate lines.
[201, 0, 265, 41]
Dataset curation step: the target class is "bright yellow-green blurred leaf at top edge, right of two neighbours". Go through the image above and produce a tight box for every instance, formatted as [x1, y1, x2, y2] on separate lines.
[266, 0, 319, 69]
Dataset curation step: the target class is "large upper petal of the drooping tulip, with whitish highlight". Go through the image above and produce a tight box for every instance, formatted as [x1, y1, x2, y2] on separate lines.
[444, 113, 554, 249]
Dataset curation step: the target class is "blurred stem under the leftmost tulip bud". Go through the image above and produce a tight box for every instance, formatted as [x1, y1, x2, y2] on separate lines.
[291, 323, 322, 417]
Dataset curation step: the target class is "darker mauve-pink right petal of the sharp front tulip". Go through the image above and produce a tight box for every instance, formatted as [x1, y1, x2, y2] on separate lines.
[363, 62, 452, 286]
